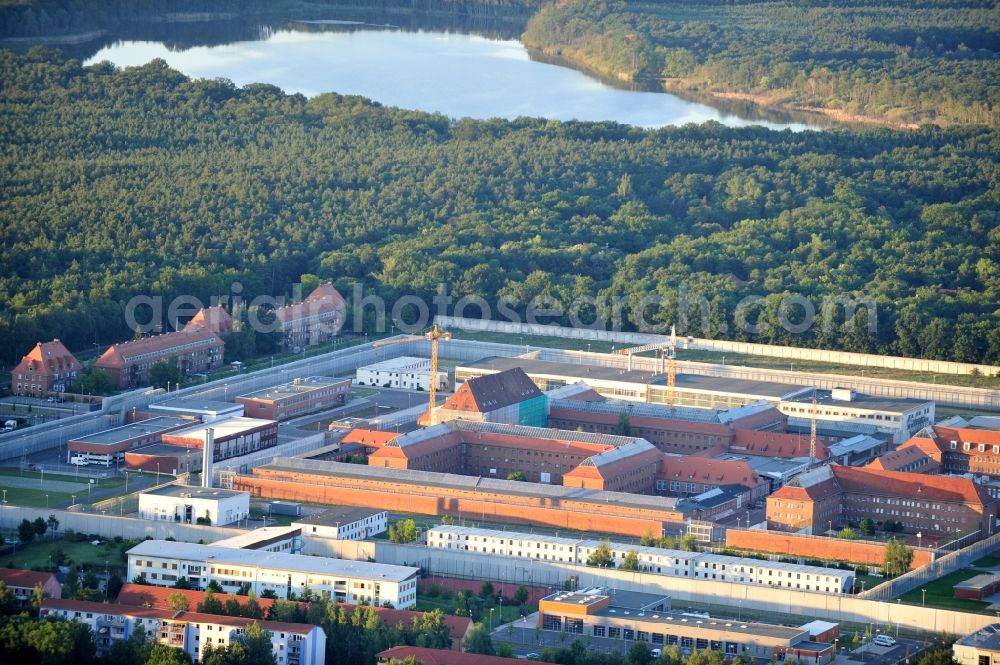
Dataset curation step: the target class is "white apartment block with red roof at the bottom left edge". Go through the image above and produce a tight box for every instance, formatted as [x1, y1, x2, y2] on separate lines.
[39, 598, 326, 665]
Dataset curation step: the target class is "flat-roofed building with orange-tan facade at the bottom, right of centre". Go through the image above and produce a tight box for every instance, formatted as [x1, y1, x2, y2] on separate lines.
[538, 592, 833, 665]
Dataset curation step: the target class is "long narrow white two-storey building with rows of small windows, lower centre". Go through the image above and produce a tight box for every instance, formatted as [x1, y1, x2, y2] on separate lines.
[427, 525, 854, 593]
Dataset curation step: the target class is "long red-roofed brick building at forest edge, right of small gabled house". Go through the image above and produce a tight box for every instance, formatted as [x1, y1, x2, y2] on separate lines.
[94, 328, 225, 388]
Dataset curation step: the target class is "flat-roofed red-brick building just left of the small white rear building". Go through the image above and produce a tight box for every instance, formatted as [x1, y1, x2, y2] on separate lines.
[236, 376, 351, 420]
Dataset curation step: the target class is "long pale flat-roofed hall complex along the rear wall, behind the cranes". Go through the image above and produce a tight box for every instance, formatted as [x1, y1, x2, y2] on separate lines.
[455, 357, 934, 444]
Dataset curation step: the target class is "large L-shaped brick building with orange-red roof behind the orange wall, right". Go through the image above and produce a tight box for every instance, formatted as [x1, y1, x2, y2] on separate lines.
[767, 465, 1000, 535]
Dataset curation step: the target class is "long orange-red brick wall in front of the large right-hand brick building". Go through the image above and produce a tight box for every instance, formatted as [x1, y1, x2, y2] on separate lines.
[726, 529, 935, 568]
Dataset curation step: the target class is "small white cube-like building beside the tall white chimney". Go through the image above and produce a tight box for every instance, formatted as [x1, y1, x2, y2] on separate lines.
[139, 485, 250, 526]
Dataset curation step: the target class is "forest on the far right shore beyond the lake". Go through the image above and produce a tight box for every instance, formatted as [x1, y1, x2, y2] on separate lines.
[523, 0, 1000, 126]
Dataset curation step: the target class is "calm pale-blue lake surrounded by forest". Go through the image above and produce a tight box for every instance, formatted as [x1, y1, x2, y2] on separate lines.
[86, 21, 807, 131]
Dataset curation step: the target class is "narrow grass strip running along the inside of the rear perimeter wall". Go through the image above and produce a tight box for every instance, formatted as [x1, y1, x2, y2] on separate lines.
[452, 329, 1000, 388]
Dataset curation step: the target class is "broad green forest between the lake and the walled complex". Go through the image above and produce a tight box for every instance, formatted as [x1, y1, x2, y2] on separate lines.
[0, 48, 1000, 363]
